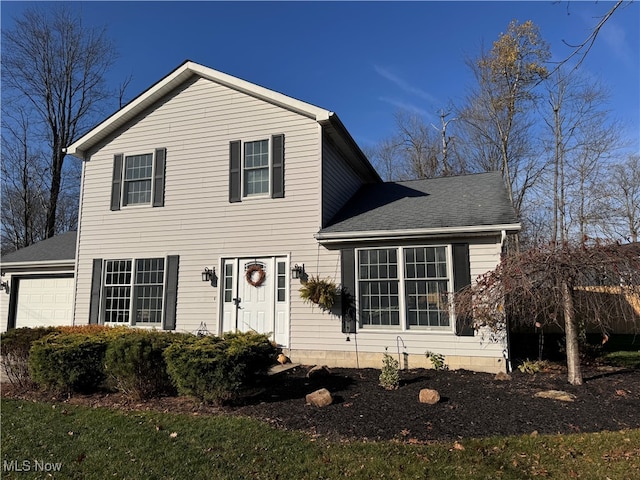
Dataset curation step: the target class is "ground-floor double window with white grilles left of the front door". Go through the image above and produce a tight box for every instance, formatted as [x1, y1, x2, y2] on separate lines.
[102, 258, 165, 327]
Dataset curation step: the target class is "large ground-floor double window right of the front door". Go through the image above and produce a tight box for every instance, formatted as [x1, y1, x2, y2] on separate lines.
[357, 246, 452, 330]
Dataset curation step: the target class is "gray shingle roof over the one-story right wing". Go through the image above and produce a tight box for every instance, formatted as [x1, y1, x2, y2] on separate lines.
[319, 172, 518, 236]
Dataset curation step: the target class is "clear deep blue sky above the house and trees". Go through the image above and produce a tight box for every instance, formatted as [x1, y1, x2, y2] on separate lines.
[1, 1, 640, 153]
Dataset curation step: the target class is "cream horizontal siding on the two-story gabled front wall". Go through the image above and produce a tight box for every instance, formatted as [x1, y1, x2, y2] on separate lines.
[75, 79, 324, 335]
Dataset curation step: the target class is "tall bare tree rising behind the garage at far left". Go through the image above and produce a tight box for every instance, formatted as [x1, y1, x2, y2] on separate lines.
[2, 4, 115, 237]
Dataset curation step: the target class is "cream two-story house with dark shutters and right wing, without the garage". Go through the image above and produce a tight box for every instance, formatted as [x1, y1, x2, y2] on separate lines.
[4, 61, 520, 372]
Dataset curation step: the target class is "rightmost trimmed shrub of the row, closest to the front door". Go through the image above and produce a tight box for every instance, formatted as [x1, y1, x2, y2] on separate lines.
[164, 333, 276, 404]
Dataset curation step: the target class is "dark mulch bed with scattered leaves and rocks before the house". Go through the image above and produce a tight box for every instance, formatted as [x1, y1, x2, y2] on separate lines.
[2, 366, 640, 443]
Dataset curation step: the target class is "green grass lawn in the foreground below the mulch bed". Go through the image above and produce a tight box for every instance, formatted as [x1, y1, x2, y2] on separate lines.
[0, 399, 640, 480]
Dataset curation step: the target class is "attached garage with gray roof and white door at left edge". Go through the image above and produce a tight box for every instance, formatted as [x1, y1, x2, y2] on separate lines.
[0, 232, 76, 331]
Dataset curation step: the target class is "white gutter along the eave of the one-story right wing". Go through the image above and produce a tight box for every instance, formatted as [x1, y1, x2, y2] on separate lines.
[314, 223, 521, 244]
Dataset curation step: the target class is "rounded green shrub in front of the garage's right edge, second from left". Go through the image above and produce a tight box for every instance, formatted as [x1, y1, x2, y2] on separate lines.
[29, 333, 107, 393]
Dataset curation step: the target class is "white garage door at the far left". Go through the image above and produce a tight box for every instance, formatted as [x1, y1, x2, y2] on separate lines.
[16, 277, 73, 328]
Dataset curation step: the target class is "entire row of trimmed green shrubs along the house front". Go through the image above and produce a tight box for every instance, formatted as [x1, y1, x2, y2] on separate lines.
[10, 326, 277, 403]
